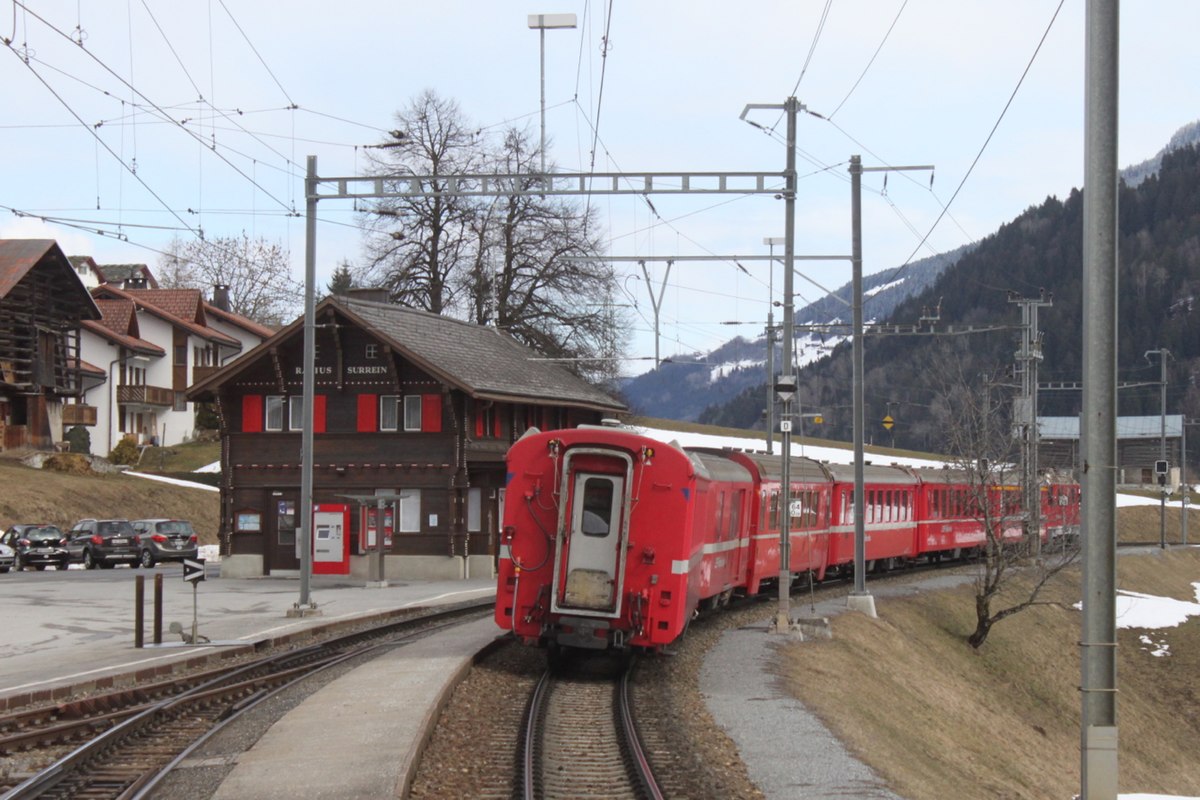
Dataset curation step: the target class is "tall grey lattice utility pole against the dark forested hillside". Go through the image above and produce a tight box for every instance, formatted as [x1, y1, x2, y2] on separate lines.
[1008, 289, 1054, 558]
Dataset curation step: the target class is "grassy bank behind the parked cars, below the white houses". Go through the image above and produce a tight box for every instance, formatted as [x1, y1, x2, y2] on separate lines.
[0, 458, 221, 545]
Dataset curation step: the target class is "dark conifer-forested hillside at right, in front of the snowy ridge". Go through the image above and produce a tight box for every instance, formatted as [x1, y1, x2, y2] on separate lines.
[701, 138, 1200, 450]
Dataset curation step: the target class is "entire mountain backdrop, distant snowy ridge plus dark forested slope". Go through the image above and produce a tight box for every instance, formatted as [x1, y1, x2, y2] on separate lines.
[624, 122, 1200, 447]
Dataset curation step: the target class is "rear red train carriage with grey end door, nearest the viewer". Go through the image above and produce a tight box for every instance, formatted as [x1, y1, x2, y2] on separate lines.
[496, 427, 751, 649]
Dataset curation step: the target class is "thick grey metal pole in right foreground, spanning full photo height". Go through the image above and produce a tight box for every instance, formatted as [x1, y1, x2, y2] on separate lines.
[1080, 0, 1120, 800]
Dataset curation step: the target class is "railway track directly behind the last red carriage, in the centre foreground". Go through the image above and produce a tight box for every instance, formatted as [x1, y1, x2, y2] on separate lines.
[517, 660, 662, 800]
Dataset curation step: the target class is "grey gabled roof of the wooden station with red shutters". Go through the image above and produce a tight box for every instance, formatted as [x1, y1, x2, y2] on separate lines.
[188, 296, 628, 411]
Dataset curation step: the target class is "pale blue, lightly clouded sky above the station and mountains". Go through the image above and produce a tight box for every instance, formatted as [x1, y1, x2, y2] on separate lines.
[0, 0, 1200, 374]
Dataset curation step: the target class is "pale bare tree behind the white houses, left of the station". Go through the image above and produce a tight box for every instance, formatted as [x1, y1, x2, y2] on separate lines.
[158, 231, 304, 325]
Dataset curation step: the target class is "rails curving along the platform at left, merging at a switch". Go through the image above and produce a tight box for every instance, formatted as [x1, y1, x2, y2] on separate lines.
[0, 602, 491, 800]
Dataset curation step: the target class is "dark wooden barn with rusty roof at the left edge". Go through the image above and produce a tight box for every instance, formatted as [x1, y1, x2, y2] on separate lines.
[0, 239, 100, 450]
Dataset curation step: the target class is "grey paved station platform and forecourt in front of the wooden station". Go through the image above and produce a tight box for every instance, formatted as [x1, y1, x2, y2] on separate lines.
[0, 564, 498, 711]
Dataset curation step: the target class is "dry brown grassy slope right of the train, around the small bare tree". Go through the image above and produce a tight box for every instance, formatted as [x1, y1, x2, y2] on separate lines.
[782, 527, 1200, 800]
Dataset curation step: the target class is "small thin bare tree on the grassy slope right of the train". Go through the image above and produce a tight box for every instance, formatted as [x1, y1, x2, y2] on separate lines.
[929, 348, 1079, 648]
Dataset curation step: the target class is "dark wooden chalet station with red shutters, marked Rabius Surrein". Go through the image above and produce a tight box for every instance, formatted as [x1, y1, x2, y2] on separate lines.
[188, 294, 628, 579]
